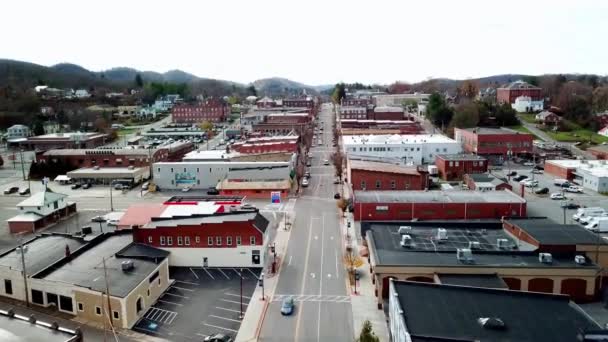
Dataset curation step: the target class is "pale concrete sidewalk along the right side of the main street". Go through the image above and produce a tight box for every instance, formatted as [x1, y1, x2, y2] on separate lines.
[341, 185, 389, 341]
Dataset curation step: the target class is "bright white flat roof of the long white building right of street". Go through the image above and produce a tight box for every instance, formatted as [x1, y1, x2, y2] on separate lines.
[342, 134, 457, 145]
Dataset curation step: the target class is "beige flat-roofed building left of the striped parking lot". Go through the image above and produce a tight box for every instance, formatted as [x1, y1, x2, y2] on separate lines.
[0, 230, 169, 329]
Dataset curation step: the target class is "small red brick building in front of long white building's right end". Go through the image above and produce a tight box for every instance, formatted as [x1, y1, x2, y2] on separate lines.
[435, 154, 488, 181]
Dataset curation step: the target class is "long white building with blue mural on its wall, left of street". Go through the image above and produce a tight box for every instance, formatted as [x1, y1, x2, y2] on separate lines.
[153, 161, 292, 189]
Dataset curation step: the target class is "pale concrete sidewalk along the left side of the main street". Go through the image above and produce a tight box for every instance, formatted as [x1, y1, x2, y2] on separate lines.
[235, 212, 295, 342]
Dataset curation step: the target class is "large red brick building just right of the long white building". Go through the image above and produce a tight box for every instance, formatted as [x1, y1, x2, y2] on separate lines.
[454, 127, 534, 164]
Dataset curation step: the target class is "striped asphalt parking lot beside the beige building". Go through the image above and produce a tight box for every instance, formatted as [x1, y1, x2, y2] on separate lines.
[133, 267, 260, 341]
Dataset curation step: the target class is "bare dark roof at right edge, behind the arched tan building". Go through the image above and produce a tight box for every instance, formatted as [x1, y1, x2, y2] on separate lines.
[506, 218, 608, 245]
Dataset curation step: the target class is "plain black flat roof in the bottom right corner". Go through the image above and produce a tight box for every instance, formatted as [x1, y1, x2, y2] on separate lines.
[393, 281, 600, 342]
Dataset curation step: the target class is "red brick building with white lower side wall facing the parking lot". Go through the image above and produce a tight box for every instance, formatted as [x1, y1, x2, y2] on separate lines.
[133, 210, 269, 267]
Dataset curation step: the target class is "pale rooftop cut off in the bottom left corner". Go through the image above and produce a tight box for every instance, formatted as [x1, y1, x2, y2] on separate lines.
[0, 310, 80, 342]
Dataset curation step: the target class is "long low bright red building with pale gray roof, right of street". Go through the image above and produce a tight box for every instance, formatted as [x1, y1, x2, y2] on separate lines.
[353, 190, 526, 221]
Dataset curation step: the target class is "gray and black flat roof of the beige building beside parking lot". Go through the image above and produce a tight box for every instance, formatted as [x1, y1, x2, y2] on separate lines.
[41, 232, 168, 297]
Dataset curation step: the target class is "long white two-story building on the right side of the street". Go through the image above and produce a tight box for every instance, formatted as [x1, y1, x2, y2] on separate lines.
[342, 134, 462, 165]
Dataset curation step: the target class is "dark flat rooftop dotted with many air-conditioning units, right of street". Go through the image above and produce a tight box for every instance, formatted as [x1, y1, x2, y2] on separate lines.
[366, 224, 599, 269]
